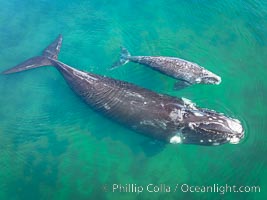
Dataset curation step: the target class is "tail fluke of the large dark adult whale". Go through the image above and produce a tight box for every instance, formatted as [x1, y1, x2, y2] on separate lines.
[2, 35, 62, 74]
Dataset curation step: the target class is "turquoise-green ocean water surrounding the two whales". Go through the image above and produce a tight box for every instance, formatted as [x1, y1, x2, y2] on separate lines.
[0, 0, 267, 200]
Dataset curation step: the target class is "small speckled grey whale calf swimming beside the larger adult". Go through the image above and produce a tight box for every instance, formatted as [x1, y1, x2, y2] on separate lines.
[110, 47, 221, 90]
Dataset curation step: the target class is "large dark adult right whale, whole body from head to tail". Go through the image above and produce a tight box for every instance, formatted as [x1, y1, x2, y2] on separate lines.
[2, 35, 244, 145]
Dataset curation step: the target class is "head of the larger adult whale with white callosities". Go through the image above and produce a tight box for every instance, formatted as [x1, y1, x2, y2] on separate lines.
[170, 100, 244, 146]
